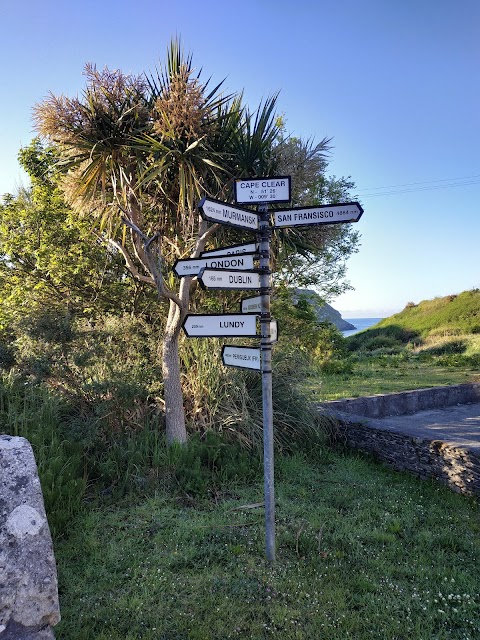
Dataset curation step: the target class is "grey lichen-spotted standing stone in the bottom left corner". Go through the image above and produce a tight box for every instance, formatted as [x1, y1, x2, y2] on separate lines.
[0, 435, 60, 640]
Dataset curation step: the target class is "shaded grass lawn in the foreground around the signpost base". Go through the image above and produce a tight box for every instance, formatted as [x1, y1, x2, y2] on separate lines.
[55, 451, 480, 640]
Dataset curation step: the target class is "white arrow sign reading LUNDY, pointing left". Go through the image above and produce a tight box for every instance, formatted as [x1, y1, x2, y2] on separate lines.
[182, 313, 257, 338]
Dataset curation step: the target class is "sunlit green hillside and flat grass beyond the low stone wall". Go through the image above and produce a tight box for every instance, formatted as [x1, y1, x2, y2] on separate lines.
[311, 290, 480, 400]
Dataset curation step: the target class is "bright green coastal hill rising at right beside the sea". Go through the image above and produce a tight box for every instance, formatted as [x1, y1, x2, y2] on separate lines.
[349, 289, 480, 349]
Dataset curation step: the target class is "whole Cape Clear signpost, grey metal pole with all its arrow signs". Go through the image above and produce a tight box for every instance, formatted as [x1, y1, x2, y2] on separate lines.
[178, 176, 363, 562]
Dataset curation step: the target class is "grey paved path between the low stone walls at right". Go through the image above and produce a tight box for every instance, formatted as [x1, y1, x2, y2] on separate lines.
[352, 403, 480, 453]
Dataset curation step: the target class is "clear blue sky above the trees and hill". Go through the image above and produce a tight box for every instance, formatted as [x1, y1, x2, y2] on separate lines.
[0, 0, 480, 317]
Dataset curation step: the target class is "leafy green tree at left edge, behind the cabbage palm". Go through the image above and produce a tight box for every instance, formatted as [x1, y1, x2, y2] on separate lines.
[0, 140, 142, 328]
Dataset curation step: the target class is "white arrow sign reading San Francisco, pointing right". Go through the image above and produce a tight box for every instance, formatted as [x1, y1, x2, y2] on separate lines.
[273, 202, 363, 228]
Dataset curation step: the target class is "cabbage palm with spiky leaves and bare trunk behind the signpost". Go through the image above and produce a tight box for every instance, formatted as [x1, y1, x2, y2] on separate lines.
[34, 40, 279, 442]
